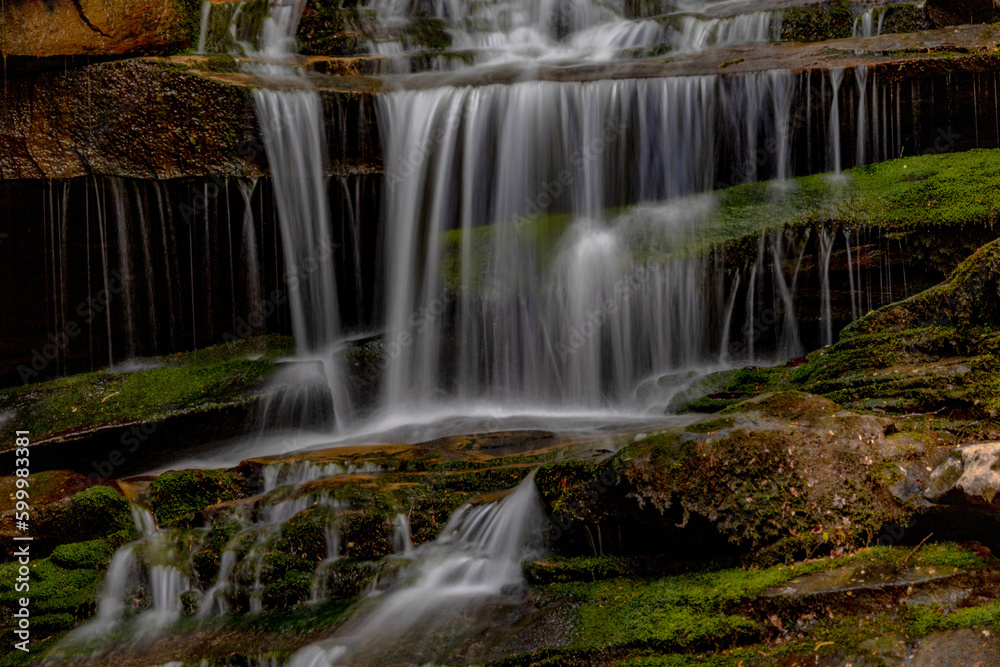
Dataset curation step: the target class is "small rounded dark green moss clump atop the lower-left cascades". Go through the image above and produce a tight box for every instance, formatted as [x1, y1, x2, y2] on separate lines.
[149, 470, 248, 526]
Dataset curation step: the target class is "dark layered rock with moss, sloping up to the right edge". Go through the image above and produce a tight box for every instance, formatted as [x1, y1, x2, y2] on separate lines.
[790, 241, 1000, 419]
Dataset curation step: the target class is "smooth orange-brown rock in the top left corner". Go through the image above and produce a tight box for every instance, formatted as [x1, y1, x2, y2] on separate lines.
[0, 0, 200, 58]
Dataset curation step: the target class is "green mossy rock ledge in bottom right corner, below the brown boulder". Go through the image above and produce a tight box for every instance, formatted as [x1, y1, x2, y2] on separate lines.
[512, 543, 998, 667]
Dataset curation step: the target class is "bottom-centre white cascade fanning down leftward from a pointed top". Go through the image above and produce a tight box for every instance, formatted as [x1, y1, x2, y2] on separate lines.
[289, 476, 545, 667]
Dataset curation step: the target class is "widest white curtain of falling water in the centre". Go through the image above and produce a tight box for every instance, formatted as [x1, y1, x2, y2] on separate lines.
[378, 73, 791, 412]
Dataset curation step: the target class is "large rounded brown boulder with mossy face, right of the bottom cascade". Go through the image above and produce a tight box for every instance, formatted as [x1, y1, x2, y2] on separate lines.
[536, 392, 931, 563]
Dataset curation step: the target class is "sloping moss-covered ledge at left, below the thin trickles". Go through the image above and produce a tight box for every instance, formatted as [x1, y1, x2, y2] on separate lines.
[0, 336, 293, 450]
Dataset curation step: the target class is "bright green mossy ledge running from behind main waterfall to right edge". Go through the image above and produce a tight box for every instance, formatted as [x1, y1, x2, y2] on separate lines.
[441, 150, 1000, 294]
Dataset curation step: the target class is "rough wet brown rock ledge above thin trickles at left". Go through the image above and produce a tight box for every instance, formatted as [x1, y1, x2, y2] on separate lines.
[0, 59, 266, 178]
